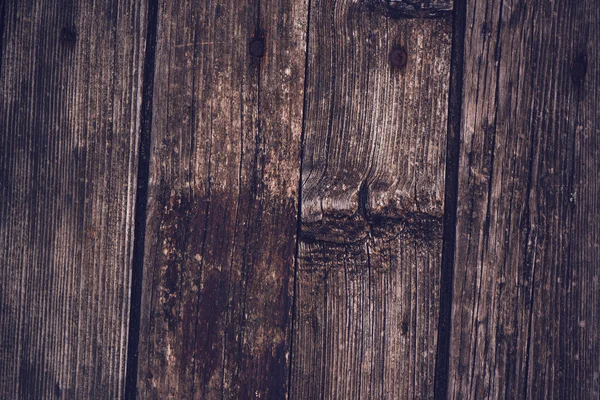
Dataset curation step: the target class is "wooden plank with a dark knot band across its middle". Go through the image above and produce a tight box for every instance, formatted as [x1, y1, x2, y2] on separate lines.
[290, 0, 452, 399]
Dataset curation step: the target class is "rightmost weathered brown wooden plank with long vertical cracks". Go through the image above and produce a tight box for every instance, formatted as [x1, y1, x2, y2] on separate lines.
[449, 0, 600, 399]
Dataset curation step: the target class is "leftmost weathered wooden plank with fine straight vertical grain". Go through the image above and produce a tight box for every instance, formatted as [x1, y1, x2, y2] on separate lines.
[0, 0, 146, 399]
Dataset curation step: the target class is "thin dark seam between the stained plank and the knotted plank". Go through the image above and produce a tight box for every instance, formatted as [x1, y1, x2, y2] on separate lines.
[287, 0, 312, 399]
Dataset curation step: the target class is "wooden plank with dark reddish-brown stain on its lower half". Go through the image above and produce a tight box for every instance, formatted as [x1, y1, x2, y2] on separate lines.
[138, 0, 308, 399]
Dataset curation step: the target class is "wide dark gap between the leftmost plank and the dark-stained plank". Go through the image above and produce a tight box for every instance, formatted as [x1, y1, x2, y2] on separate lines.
[125, 0, 158, 400]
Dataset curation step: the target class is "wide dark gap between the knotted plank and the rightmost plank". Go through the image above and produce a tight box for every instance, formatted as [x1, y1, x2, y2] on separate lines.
[433, 0, 466, 399]
